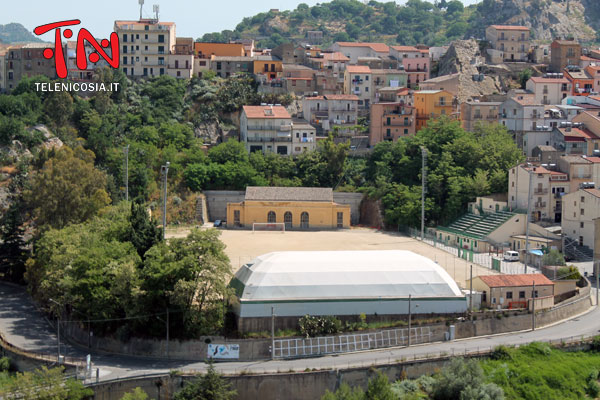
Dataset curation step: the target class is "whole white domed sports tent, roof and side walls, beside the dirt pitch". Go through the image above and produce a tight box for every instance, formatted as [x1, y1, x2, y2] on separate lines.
[231, 250, 467, 331]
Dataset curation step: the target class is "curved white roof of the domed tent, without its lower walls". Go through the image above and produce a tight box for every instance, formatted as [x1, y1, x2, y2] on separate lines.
[232, 250, 464, 302]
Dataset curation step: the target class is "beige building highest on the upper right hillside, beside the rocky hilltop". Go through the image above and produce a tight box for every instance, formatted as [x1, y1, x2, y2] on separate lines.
[485, 25, 531, 61]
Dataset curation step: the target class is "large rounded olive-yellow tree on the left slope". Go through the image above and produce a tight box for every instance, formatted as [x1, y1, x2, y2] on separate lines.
[25, 147, 110, 229]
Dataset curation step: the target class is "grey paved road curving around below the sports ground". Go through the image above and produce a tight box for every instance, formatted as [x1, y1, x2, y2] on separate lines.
[0, 283, 600, 381]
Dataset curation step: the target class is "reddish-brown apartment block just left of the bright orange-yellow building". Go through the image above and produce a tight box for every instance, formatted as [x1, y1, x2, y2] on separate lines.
[369, 102, 416, 146]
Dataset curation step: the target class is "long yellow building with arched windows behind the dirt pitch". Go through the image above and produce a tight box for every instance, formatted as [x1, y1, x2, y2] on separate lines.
[227, 186, 350, 230]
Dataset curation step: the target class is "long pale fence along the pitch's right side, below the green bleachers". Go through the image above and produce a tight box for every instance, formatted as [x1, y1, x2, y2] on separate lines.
[405, 228, 539, 274]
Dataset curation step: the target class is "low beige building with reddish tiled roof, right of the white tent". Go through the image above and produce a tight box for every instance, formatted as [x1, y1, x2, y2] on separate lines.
[467, 274, 554, 309]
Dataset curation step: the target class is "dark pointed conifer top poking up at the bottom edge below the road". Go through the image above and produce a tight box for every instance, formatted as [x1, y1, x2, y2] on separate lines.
[174, 362, 237, 400]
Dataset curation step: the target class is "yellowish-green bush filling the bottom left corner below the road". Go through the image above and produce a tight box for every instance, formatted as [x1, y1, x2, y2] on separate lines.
[0, 367, 94, 400]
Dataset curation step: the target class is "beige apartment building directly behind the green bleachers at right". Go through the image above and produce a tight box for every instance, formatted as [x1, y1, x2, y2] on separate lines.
[508, 164, 570, 222]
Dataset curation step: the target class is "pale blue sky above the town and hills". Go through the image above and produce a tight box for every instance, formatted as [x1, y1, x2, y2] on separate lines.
[0, 0, 481, 41]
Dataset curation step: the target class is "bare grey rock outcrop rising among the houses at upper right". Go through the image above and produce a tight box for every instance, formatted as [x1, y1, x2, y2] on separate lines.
[438, 39, 502, 102]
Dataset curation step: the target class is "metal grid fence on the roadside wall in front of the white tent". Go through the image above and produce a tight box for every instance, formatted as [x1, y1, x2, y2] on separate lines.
[273, 327, 432, 358]
